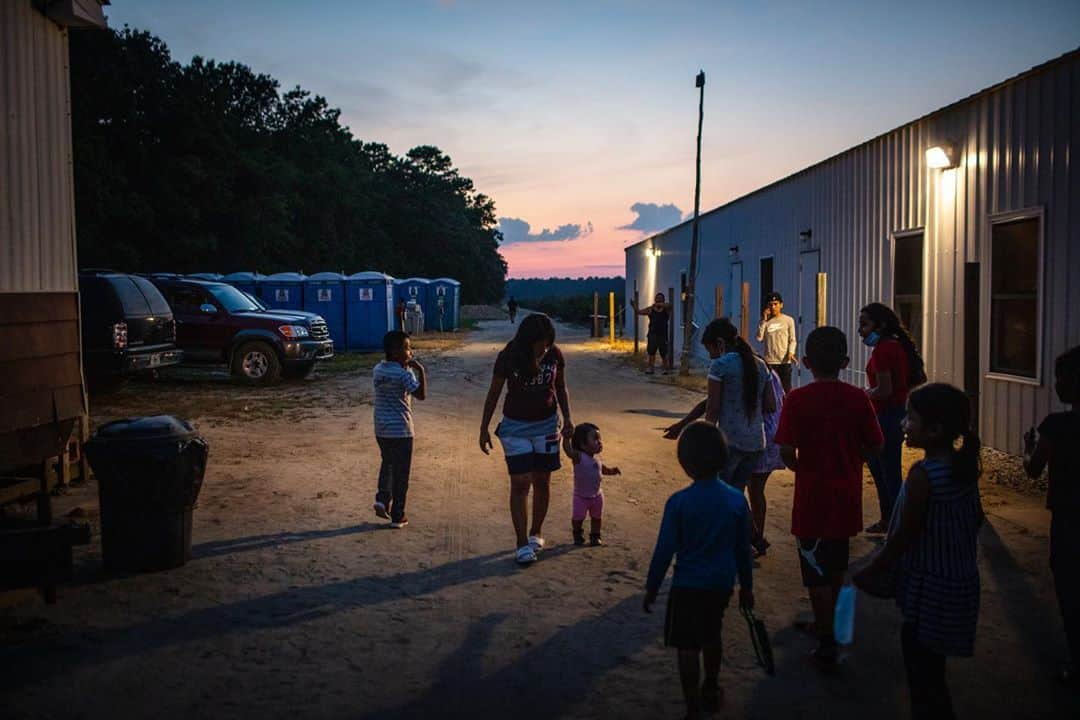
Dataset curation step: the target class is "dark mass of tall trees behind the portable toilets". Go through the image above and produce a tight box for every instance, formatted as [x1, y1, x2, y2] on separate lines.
[71, 28, 507, 302]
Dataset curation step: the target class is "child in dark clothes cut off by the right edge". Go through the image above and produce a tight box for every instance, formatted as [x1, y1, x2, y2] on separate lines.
[1024, 345, 1080, 687]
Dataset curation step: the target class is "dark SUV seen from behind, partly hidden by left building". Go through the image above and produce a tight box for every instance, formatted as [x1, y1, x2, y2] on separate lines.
[79, 270, 184, 390]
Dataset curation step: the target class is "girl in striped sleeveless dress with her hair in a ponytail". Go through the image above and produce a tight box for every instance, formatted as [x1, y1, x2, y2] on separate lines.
[855, 383, 983, 718]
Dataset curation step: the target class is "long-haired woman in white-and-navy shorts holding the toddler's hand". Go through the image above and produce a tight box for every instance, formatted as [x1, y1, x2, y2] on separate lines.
[480, 313, 573, 565]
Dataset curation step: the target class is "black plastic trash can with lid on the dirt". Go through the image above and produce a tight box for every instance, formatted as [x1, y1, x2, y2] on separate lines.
[86, 415, 208, 572]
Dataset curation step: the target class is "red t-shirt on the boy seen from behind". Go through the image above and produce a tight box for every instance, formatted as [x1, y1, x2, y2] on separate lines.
[775, 382, 885, 540]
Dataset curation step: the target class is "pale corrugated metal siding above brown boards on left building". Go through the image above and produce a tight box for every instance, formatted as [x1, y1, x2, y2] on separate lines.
[0, 0, 76, 293]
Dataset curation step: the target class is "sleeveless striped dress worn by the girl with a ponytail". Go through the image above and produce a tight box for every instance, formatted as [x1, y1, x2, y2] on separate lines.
[892, 460, 981, 656]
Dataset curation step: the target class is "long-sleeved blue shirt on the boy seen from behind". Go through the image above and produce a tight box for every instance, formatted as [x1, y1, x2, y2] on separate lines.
[645, 478, 754, 593]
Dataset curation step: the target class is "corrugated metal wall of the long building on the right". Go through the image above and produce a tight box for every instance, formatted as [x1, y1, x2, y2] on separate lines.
[625, 53, 1080, 452]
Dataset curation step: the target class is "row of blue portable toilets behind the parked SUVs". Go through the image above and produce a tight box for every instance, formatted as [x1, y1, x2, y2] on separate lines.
[188, 271, 461, 350]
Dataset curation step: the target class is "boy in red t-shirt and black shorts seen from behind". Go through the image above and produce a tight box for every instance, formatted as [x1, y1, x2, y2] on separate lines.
[775, 326, 885, 667]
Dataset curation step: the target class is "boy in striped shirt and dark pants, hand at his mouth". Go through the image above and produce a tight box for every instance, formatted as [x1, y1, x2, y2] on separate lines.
[372, 330, 428, 528]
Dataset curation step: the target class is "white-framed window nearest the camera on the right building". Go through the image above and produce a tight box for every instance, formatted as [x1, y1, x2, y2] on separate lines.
[990, 217, 1042, 379]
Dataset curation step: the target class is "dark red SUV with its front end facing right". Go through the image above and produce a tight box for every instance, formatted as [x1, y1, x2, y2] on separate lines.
[150, 275, 334, 385]
